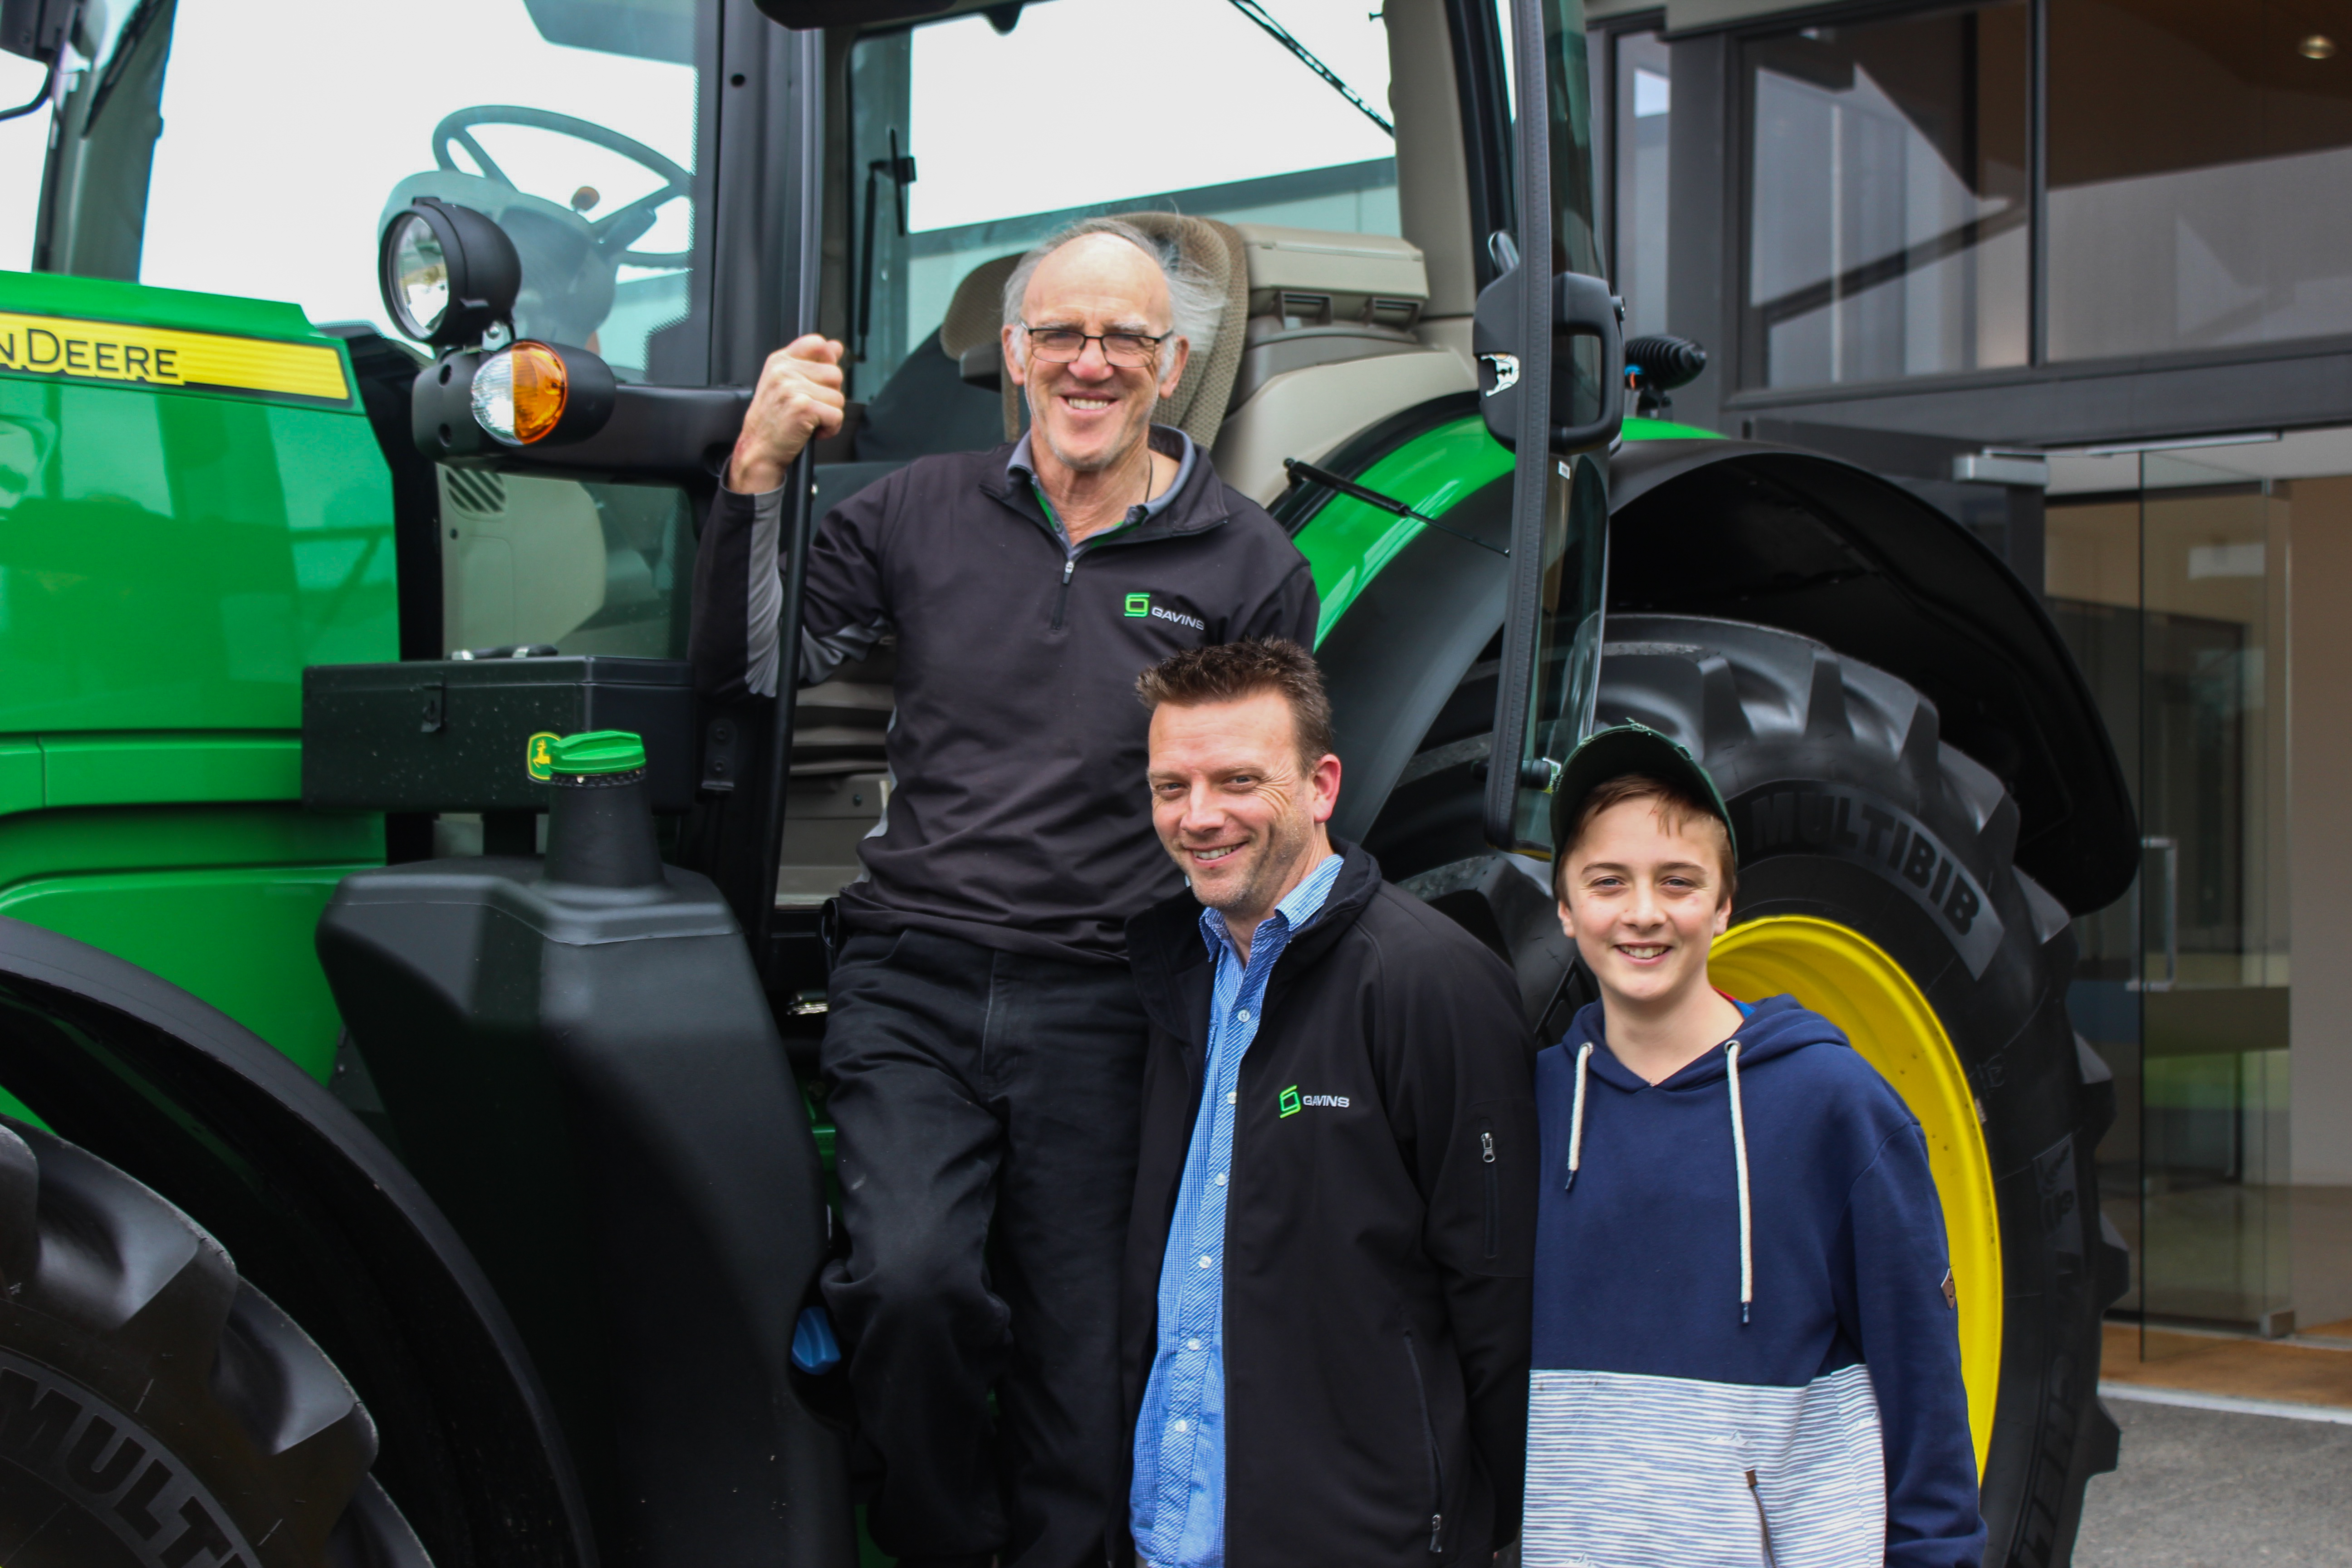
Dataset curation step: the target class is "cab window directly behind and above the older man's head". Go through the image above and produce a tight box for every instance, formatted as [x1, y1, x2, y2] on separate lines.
[849, 0, 1399, 397]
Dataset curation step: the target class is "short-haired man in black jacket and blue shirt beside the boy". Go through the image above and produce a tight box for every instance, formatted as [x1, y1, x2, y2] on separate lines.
[1110, 642, 1536, 1568]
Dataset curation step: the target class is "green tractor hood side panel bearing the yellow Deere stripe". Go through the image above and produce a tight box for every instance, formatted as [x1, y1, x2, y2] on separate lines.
[0, 273, 397, 1077]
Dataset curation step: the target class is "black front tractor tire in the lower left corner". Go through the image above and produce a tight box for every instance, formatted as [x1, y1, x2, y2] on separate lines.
[0, 1119, 431, 1568]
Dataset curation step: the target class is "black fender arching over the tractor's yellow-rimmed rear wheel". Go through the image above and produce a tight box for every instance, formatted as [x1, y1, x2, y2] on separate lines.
[1609, 440, 2140, 915]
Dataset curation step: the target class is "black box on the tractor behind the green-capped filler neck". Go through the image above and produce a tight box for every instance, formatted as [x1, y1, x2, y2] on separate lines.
[301, 653, 696, 813]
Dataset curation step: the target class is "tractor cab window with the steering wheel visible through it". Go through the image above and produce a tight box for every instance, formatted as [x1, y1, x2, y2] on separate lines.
[80, 0, 713, 383]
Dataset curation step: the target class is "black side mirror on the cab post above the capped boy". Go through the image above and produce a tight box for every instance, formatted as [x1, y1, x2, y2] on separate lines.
[1470, 265, 1625, 456]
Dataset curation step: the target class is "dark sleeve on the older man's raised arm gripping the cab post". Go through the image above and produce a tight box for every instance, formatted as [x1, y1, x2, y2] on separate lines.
[687, 484, 889, 703]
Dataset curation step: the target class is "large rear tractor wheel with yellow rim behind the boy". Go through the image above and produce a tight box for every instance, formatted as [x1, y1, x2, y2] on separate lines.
[1599, 613, 2129, 1568]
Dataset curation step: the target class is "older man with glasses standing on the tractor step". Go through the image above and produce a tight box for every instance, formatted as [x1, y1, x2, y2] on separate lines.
[691, 219, 1315, 1568]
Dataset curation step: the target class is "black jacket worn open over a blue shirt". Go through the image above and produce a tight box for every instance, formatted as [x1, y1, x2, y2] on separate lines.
[1110, 846, 1536, 1568]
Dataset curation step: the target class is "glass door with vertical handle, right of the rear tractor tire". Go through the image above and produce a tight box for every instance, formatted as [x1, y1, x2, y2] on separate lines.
[2138, 451, 2291, 1349]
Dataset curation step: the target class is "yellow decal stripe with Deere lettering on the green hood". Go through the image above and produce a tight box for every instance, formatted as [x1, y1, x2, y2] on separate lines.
[0, 313, 350, 402]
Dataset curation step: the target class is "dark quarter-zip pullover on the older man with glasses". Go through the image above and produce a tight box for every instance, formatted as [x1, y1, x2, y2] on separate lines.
[691, 444, 1317, 961]
